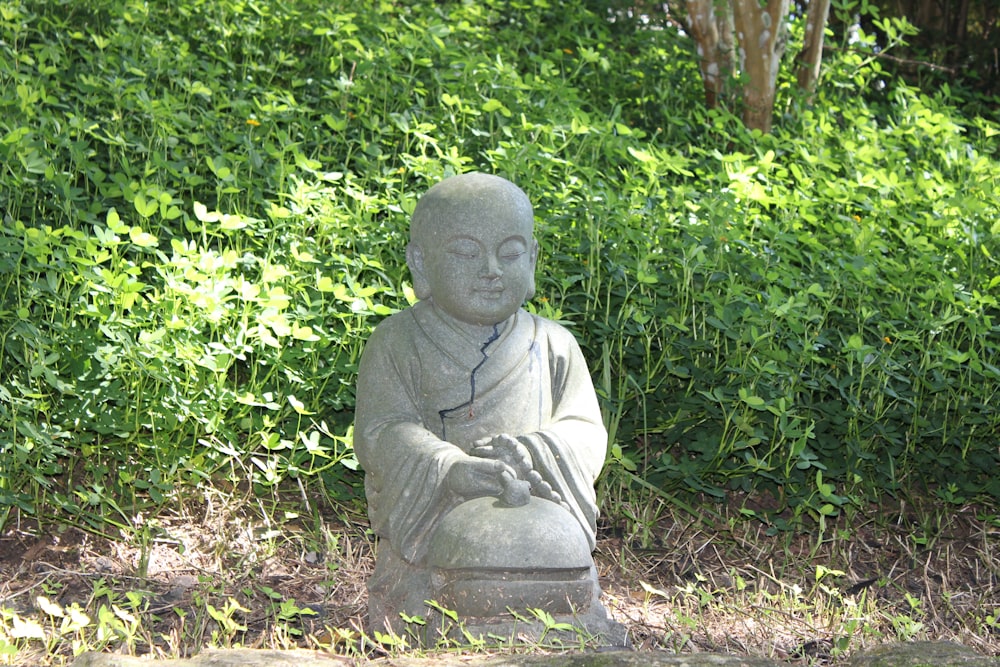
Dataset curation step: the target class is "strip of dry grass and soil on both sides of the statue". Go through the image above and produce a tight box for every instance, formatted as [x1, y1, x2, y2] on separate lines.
[0, 491, 1000, 665]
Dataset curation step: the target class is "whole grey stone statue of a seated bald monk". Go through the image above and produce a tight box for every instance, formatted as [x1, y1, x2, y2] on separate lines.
[354, 173, 624, 644]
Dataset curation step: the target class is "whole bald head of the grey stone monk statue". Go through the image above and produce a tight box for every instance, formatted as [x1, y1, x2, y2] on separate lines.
[406, 173, 538, 326]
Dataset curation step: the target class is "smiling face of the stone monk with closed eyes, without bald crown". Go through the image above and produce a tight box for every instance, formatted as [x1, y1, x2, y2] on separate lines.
[407, 204, 538, 326]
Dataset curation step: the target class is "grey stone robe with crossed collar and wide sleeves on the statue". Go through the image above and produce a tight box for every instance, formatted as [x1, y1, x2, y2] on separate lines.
[354, 300, 607, 621]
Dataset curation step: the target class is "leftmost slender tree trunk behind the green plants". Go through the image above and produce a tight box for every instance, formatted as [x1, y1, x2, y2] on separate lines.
[687, 0, 733, 109]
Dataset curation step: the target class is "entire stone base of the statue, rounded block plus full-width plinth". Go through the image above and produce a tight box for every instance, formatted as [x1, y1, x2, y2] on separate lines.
[369, 497, 628, 646]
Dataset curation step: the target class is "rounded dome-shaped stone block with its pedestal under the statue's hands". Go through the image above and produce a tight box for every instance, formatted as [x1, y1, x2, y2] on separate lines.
[427, 497, 626, 645]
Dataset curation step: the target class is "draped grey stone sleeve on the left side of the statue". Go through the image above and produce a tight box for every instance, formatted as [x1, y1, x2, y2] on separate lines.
[354, 318, 464, 563]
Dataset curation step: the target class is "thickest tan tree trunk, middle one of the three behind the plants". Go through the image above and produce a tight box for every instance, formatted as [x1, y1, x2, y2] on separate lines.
[733, 0, 790, 133]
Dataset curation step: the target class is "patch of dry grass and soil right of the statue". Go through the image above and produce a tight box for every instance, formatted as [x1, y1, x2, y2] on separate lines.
[600, 490, 1000, 664]
